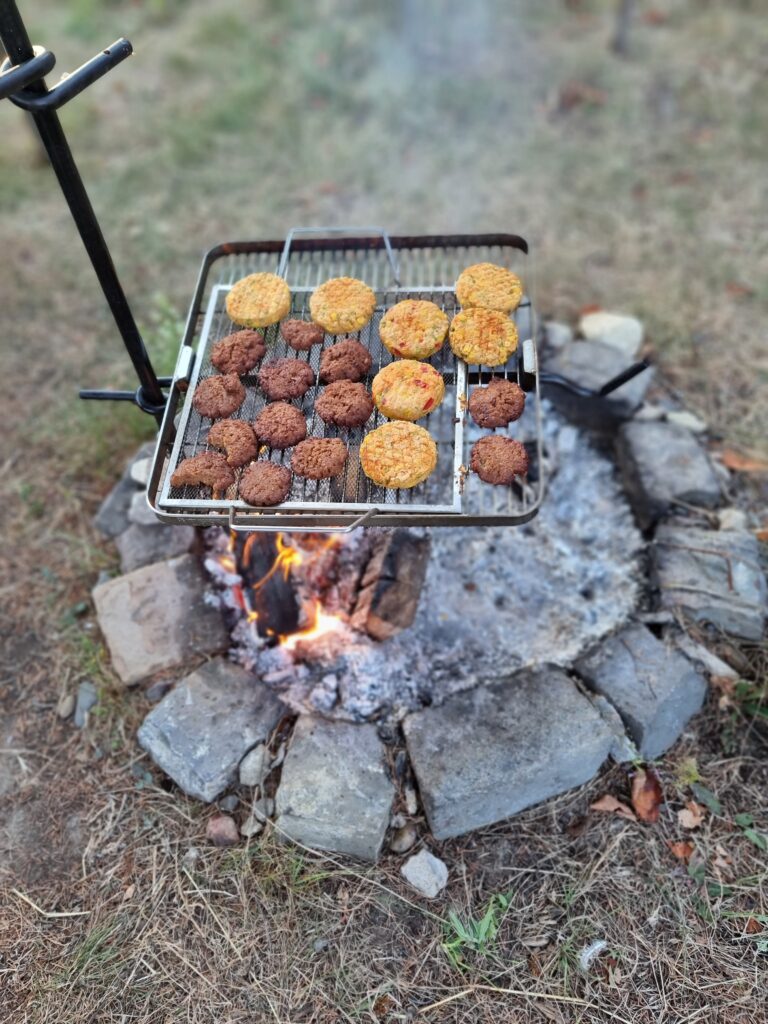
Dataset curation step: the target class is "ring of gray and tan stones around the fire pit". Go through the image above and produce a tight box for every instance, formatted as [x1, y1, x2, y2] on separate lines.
[93, 313, 766, 872]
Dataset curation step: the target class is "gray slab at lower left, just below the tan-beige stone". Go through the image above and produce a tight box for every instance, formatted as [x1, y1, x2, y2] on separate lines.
[138, 658, 285, 803]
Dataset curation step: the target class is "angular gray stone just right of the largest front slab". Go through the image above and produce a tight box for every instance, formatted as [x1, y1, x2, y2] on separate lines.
[575, 625, 707, 760]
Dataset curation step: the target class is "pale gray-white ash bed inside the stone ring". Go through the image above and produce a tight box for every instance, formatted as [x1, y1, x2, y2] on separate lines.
[207, 408, 642, 721]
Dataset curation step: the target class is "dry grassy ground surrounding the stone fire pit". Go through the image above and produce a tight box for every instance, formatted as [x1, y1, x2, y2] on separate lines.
[0, 0, 768, 1024]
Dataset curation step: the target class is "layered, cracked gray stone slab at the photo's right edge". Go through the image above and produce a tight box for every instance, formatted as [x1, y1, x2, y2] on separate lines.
[651, 523, 768, 640]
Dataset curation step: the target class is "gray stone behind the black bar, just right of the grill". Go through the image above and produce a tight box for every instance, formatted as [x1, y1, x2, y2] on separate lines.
[544, 341, 653, 429]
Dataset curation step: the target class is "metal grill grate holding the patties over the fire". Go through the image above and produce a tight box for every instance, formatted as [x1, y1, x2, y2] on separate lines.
[150, 239, 544, 529]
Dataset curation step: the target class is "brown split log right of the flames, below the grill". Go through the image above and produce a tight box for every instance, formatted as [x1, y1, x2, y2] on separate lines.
[351, 529, 430, 640]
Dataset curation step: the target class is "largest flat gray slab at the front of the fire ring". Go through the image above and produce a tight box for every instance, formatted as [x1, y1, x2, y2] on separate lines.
[403, 669, 614, 840]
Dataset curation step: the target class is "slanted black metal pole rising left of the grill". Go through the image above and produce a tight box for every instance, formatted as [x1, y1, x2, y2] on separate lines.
[0, 0, 166, 424]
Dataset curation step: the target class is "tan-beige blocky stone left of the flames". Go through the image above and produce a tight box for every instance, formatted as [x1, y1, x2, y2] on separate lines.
[93, 555, 229, 684]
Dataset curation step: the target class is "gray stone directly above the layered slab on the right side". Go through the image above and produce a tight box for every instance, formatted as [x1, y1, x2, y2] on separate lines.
[616, 422, 721, 528]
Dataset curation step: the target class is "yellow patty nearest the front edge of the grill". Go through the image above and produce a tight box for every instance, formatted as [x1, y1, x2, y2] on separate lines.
[360, 420, 437, 488]
